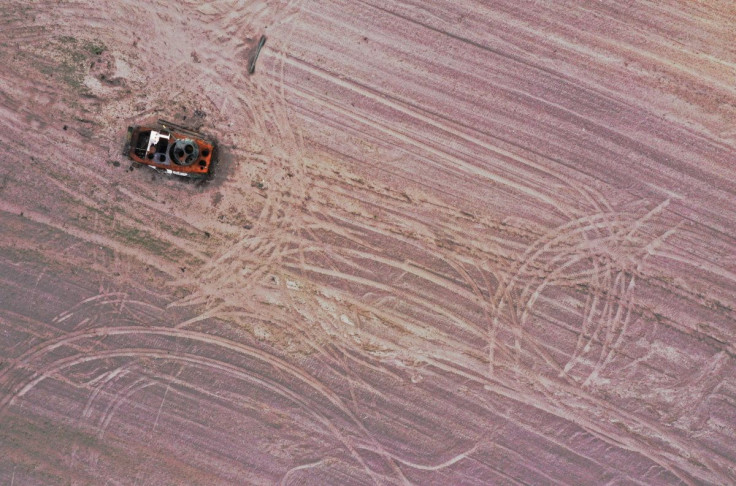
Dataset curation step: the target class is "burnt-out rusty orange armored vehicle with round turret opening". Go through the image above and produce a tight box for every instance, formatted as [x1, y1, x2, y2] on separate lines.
[123, 120, 215, 179]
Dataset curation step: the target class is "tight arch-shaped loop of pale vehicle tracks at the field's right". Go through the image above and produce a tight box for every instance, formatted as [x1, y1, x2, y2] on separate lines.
[491, 201, 674, 385]
